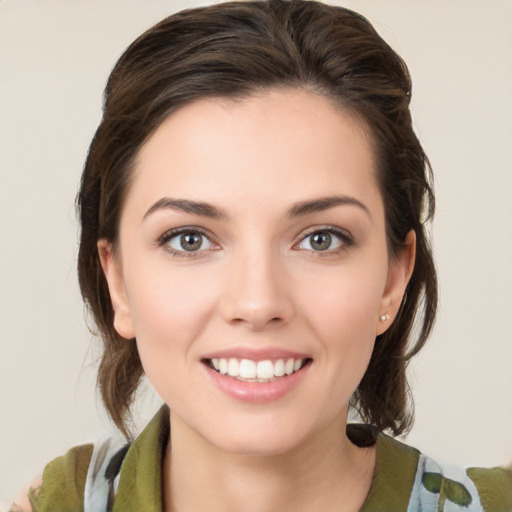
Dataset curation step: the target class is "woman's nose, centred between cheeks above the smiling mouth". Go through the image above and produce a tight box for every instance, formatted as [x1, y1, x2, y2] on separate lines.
[220, 245, 293, 331]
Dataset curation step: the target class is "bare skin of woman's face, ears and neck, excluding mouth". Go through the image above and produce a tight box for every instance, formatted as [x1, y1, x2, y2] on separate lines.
[98, 89, 415, 512]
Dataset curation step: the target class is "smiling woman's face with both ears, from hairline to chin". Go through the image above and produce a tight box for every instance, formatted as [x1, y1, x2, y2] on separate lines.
[99, 89, 414, 454]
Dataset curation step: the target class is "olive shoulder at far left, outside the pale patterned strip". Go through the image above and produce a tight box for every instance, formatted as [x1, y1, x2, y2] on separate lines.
[11, 444, 93, 512]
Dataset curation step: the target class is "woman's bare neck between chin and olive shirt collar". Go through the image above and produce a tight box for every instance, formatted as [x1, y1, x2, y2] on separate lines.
[164, 415, 376, 512]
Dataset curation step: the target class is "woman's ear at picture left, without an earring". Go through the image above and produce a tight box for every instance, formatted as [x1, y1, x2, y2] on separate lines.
[98, 239, 135, 339]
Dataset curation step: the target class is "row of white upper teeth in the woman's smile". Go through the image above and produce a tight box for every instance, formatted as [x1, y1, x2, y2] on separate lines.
[211, 357, 304, 382]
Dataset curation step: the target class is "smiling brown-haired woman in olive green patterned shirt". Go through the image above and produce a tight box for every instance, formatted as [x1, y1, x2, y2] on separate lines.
[10, 0, 512, 511]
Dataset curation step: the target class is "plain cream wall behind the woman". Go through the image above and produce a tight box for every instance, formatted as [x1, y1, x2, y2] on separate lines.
[0, 0, 512, 501]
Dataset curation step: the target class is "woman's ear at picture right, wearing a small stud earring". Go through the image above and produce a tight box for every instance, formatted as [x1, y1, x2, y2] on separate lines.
[376, 229, 416, 336]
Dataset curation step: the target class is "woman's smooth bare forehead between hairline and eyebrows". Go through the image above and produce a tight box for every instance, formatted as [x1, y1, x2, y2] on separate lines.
[127, 89, 380, 220]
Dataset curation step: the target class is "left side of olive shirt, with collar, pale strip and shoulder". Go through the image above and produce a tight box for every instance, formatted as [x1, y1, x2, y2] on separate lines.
[10, 407, 169, 512]
